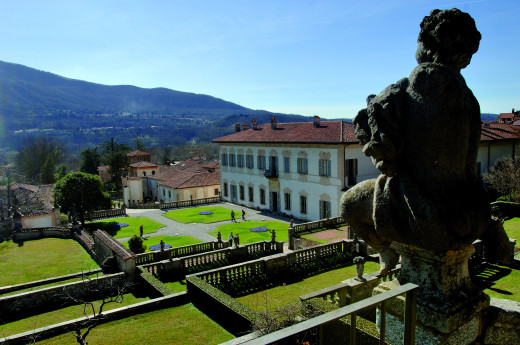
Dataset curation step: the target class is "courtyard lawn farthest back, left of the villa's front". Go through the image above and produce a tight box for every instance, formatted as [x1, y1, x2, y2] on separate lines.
[163, 206, 242, 223]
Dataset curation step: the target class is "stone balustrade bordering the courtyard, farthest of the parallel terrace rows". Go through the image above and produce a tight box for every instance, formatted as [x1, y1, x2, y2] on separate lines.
[135, 241, 229, 266]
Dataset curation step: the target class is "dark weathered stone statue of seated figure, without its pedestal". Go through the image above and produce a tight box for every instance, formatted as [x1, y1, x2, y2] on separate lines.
[340, 9, 508, 274]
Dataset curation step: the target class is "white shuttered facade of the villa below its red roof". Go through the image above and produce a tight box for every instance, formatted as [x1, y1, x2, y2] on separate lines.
[219, 143, 379, 220]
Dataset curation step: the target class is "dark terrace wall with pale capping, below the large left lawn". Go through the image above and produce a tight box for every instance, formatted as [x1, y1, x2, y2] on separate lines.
[0, 273, 126, 322]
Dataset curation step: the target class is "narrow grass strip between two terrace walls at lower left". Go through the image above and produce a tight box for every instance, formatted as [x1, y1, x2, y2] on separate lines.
[0, 294, 149, 339]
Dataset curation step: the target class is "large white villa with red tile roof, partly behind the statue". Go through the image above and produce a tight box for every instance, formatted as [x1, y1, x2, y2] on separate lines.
[213, 116, 518, 221]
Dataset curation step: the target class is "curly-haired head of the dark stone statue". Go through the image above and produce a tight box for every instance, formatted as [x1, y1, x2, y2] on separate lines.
[415, 8, 482, 69]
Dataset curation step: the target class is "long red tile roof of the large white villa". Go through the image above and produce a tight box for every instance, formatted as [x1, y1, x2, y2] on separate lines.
[212, 121, 359, 144]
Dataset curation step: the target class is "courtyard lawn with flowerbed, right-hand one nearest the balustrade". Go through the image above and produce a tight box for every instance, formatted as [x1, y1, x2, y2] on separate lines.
[209, 221, 289, 244]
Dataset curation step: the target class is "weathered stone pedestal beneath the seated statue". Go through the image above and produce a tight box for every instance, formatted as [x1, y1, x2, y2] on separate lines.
[374, 245, 489, 344]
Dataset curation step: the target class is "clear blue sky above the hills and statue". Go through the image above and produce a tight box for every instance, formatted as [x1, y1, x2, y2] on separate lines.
[0, 0, 520, 118]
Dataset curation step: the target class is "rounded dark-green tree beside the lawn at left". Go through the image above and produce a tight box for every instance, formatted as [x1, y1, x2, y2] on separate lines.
[54, 172, 110, 225]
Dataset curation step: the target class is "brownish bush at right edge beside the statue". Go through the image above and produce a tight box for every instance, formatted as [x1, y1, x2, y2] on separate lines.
[483, 158, 520, 202]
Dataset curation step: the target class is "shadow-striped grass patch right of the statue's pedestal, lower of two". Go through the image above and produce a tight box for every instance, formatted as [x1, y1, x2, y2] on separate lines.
[475, 264, 520, 302]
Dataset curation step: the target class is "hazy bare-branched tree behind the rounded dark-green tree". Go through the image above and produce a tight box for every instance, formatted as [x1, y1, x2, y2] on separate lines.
[16, 137, 65, 182]
